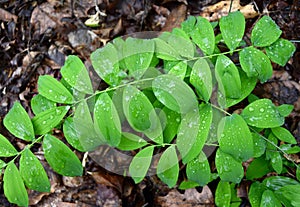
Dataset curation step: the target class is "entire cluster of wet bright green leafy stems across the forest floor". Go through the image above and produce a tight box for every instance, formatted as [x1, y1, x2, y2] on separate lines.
[0, 12, 300, 206]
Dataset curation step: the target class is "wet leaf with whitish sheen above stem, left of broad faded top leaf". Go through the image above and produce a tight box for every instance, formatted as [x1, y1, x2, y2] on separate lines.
[91, 43, 120, 86]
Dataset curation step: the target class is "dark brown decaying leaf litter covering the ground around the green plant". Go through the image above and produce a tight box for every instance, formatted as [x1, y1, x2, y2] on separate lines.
[0, 0, 300, 206]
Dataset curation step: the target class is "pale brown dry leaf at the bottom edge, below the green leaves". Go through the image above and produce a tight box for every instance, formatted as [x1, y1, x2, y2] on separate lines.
[156, 186, 214, 207]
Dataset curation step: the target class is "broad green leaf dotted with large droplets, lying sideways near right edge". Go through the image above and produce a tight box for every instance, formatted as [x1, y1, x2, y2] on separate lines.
[241, 99, 284, 128]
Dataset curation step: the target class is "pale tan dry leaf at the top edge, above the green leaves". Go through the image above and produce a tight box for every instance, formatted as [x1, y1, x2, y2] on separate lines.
[200, 0, 259, 21]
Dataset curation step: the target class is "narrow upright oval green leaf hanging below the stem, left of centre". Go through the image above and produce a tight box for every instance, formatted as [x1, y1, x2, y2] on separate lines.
[94, 93, 121, 146]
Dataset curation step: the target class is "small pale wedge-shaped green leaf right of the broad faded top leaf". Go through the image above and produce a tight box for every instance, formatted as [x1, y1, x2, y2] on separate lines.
[154, 38, 181, 60]
